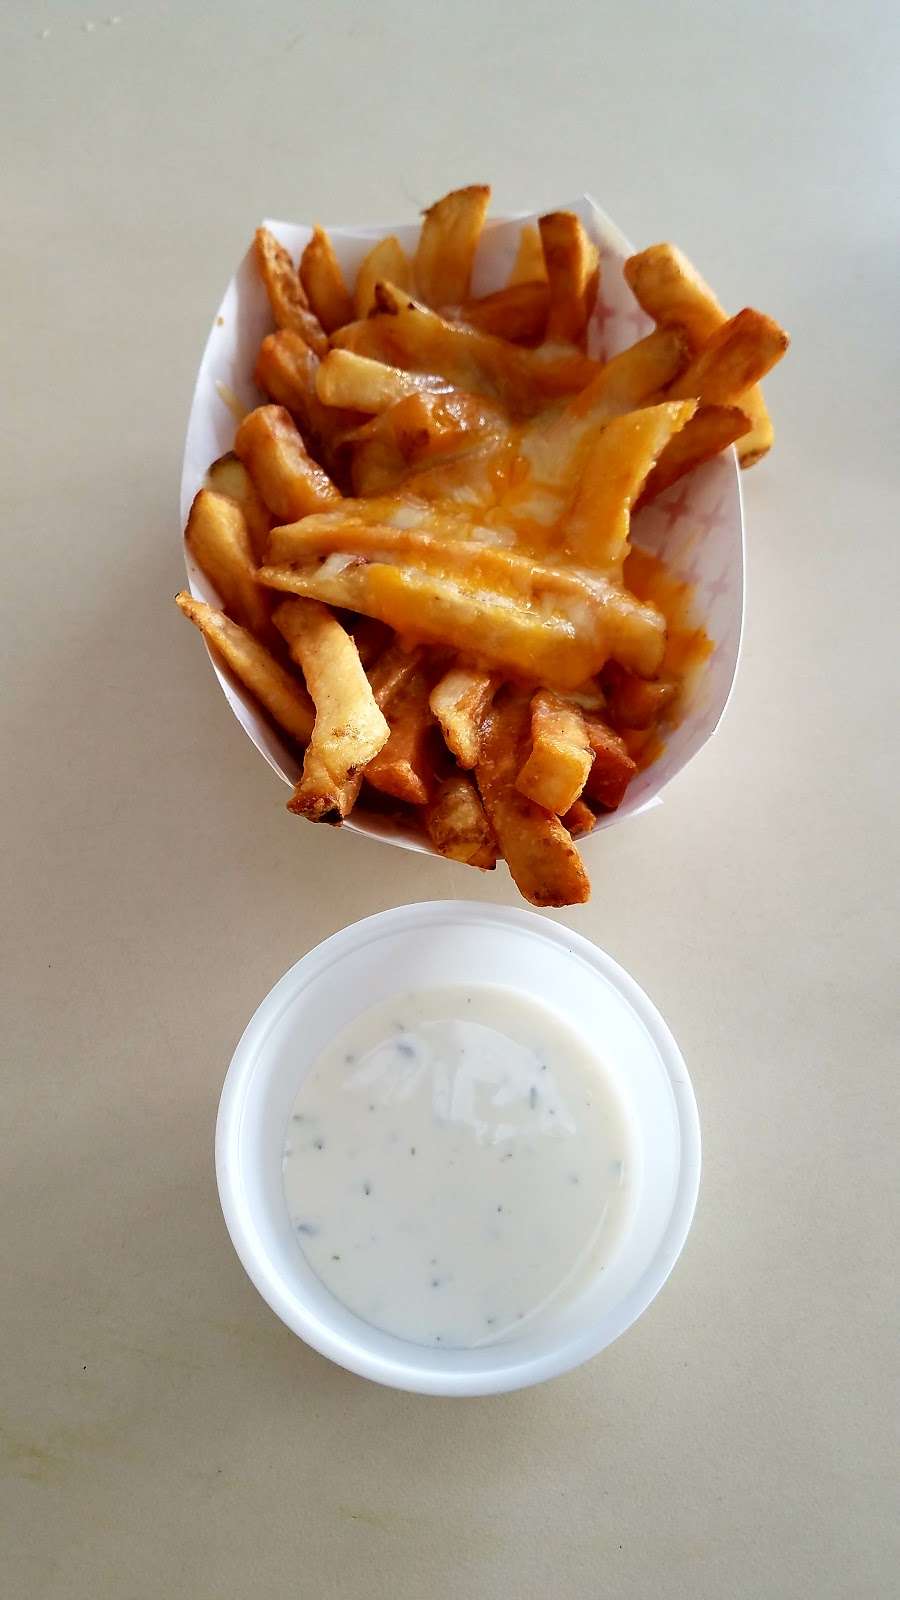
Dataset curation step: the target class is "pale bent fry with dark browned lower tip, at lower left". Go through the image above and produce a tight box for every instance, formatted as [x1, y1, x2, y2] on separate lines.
[274, 600, 391, 822]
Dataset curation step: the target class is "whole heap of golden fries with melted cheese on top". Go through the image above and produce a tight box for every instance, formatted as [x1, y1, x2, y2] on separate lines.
[178, 184, 788, 906]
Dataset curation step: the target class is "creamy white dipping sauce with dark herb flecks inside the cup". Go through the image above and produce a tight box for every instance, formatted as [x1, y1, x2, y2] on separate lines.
[282, 984, 633, 1347]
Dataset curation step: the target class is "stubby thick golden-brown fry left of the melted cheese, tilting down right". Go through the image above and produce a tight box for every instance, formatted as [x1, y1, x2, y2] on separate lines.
[234, 405, 341, 522]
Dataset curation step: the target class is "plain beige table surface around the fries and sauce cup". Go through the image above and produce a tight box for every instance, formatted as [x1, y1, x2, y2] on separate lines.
[0, 0, 900, 1600]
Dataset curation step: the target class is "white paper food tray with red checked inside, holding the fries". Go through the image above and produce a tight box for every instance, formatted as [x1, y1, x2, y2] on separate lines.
[181, 195, 743, 854]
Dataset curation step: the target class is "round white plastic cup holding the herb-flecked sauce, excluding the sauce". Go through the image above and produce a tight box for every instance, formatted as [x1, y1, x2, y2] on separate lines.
[216, 901, 700, 1395]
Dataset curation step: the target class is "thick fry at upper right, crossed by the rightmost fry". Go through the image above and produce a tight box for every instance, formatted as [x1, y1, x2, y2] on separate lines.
[623, 243, 775, 467]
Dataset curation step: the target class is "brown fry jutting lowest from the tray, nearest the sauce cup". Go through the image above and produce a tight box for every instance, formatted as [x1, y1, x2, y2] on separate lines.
[476, 690, 591, 906]
